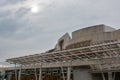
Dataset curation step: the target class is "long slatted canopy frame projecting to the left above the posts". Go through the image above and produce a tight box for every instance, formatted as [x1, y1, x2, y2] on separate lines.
[6, 41, 120, 65]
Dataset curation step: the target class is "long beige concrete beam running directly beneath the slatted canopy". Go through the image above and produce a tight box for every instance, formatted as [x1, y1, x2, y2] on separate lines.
[0, 57, 120, 70]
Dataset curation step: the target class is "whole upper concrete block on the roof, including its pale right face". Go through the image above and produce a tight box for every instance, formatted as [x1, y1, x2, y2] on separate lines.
[67, 24, 115, 44]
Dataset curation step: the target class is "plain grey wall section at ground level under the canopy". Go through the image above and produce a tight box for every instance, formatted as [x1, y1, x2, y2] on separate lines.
[73, 69, 92, 80]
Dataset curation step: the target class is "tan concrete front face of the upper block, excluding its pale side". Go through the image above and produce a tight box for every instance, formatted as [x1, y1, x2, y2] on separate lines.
[72, 25, 104, 43]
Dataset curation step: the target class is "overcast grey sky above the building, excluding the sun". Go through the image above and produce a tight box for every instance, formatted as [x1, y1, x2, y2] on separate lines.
[0, 0, 120, 65]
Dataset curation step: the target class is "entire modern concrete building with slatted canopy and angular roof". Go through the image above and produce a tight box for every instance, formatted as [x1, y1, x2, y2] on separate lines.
[1, 24, 120, 80]
